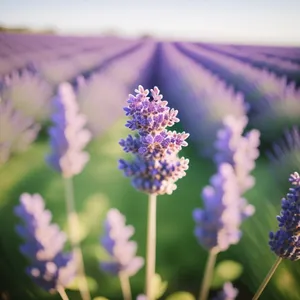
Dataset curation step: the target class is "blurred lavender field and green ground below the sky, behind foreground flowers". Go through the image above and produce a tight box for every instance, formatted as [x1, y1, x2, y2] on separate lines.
[0, 33, 300, 300]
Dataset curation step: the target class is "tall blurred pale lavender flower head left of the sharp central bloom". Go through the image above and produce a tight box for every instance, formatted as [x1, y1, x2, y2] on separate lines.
[47, 83, 91, 178]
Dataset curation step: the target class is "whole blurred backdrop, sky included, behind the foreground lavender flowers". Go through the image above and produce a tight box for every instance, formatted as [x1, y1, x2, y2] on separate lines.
[0, 0, 300, 300]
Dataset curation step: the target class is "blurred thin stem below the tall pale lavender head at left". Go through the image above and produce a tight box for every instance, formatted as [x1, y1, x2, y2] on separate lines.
[64, 178, 91, 300]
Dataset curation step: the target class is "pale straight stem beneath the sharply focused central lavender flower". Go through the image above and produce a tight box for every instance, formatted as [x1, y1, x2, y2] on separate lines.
[146, 194, 157, 300]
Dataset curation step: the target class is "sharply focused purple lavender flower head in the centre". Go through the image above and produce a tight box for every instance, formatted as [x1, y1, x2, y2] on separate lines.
[119, 85, 189, 194]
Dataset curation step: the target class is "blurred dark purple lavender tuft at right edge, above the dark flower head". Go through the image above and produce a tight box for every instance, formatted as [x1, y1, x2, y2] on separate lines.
[267, 126, 300, 184]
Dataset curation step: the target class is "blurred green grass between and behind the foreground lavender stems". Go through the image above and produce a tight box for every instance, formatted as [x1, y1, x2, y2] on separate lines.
[0, 120, 300, 300]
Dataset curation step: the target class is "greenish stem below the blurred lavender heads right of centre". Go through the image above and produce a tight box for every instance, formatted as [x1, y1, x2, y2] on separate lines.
[199, 248, 219, 300]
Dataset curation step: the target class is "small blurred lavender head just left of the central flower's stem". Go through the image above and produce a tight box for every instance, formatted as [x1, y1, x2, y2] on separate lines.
[100, 208, 144, 276]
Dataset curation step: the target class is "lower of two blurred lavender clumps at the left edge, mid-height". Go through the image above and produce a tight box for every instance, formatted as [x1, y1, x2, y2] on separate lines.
[0, 98, 41, 165]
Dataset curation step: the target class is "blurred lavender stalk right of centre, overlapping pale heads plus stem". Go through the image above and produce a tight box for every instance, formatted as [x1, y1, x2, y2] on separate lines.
[193, 115, 260, 300]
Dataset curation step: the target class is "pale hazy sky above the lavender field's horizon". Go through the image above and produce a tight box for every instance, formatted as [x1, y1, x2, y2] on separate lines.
[0, 0, 300, 46]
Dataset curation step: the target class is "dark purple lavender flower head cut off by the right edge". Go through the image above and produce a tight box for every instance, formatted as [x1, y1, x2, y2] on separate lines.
[269, 172, 300, 261]
